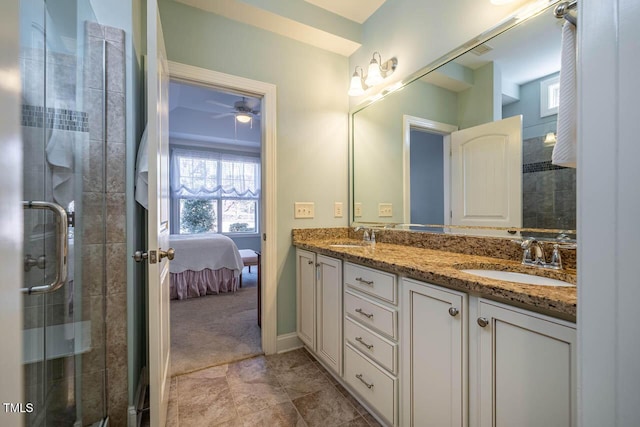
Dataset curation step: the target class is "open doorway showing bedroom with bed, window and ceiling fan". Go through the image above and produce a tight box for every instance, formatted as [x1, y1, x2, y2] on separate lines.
[169, 79, 263, 376]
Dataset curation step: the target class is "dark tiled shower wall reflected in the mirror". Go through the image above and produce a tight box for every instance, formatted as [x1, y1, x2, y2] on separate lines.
[522, 136, 576, 230]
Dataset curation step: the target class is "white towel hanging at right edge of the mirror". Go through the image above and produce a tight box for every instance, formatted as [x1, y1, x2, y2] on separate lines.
[551, 21, 577, 168]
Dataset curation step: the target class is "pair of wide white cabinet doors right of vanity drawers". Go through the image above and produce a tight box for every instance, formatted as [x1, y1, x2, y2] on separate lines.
[400, 278, 577, 427]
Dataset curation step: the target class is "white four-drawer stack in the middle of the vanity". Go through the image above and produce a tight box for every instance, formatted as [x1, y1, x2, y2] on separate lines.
[343, 262, 399, 426]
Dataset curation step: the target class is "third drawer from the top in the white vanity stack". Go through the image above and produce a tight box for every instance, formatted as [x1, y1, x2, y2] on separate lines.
[344, 317, 398, 374]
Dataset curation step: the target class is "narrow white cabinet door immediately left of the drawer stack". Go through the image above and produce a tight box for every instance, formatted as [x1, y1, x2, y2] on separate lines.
[316, 255, 342, 375]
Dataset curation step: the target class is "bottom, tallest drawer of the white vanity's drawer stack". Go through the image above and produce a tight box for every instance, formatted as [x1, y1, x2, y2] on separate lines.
[344, 344, 398, 425]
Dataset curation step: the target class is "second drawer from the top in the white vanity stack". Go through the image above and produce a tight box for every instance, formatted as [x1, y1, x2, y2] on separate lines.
[344, 291, 398, 339]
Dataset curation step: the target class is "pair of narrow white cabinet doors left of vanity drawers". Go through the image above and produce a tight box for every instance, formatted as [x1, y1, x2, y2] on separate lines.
[296, 249, 342, 375]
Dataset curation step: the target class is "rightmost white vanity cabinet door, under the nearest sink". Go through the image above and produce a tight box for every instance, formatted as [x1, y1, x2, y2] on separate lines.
[474, 300, 577, 427]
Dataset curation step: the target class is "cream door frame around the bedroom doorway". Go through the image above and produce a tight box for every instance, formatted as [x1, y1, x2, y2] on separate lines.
[169, 61, 277, 354]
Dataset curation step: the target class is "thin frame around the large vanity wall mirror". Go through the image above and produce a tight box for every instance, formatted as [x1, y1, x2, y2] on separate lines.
[349, 0, 576, 235]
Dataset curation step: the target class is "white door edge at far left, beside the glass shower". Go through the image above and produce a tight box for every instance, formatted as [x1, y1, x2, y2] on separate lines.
[0, 1, 26, 426]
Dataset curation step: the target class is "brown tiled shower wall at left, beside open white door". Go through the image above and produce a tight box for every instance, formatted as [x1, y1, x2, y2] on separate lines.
[83, 23, 128, 426]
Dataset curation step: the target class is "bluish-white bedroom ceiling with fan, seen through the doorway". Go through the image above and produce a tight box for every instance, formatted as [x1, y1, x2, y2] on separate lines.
[169, 81, 261, 152]
